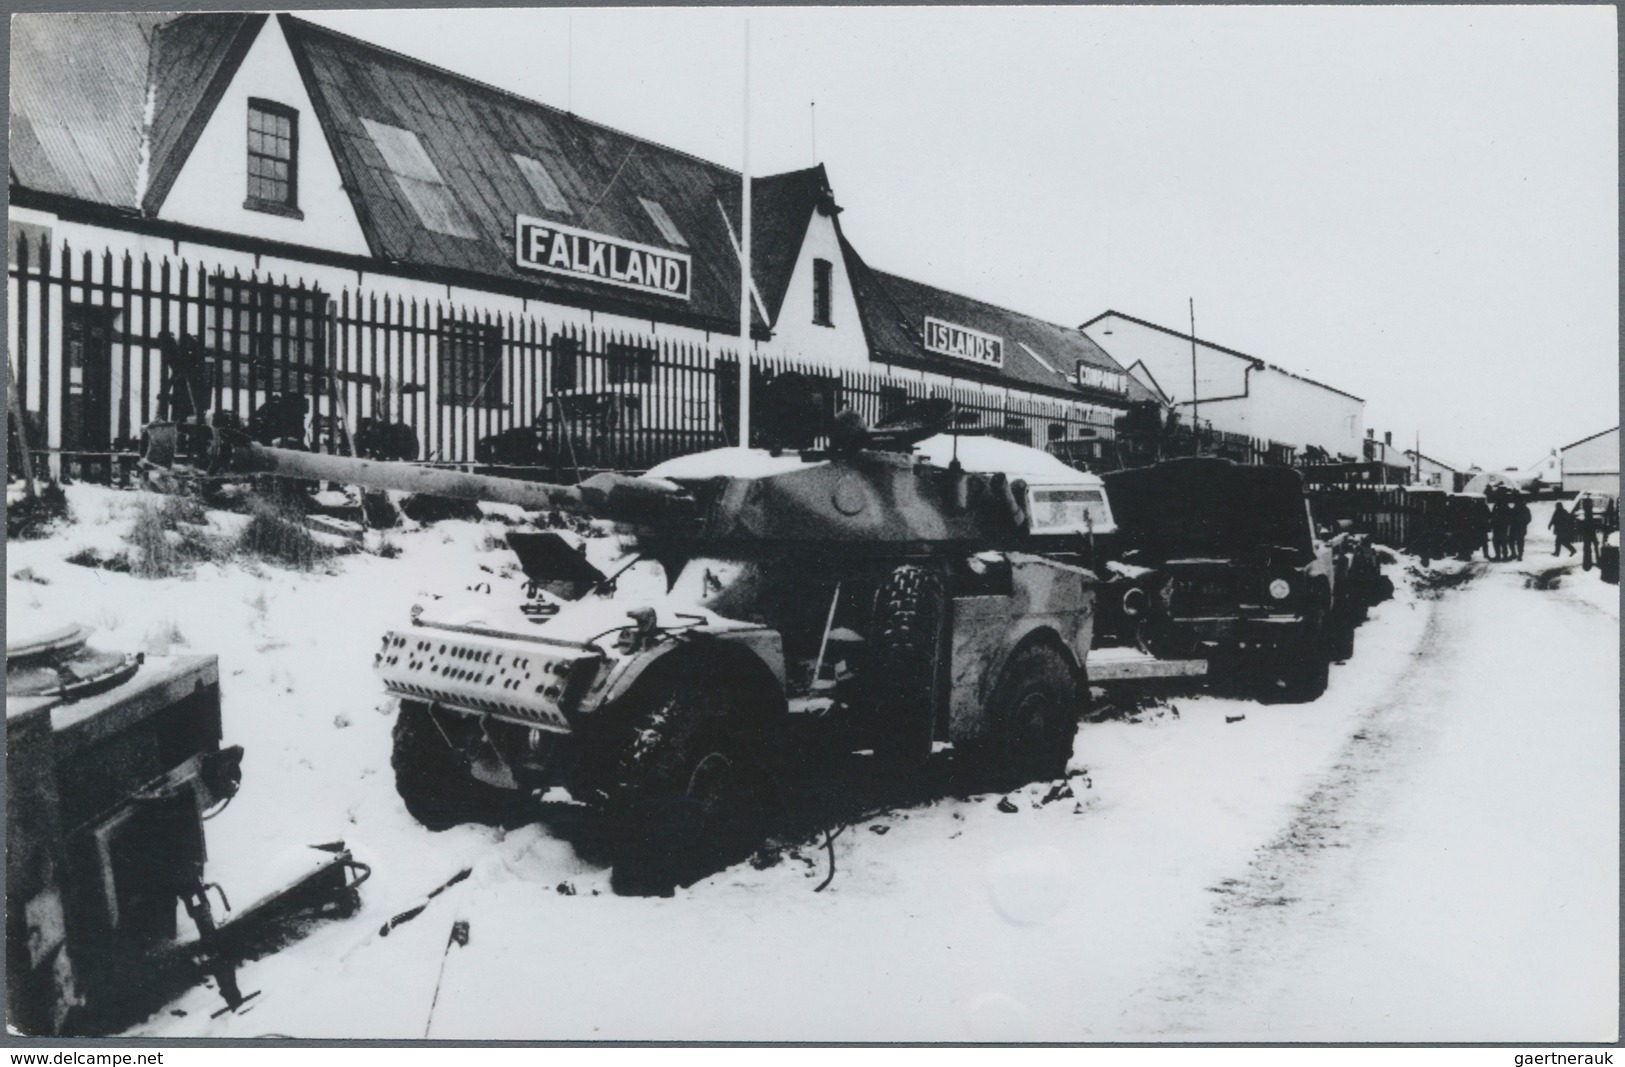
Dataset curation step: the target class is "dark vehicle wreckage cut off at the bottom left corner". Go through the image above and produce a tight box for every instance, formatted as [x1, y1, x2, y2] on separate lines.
[7, 625, 366, 1036]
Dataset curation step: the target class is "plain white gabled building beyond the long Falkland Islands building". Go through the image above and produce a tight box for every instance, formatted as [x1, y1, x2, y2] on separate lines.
[1081, 310, 1365, 463]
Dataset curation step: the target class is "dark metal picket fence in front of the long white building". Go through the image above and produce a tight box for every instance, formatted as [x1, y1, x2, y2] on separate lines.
[7, 237, 1113, 479]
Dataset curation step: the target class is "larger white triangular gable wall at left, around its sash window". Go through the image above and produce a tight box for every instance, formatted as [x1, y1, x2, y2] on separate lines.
[158, 16, 371, 255]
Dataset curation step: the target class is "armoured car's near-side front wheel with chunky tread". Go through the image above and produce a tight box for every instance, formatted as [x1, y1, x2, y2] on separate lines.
[608, 679, 770, 895]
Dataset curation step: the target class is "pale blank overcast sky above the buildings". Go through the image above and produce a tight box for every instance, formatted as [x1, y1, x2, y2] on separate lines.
[306, 6, 1619, 468]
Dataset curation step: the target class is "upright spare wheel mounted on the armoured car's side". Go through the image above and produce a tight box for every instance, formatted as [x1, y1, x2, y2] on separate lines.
[869, 564, 946, 770]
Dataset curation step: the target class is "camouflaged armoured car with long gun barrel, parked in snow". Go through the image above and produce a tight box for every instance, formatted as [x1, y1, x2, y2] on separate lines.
[146, 401, 1110, 883]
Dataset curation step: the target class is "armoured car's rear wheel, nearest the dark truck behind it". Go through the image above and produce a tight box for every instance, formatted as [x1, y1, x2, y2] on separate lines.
[969, 645, 1079, 789]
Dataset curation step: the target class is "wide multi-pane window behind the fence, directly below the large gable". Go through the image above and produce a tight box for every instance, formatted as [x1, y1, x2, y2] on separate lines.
[203, 276, 327, 393]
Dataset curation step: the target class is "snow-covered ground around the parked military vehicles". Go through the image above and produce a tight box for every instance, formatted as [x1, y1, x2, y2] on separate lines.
[7, 487, 1619, 1041]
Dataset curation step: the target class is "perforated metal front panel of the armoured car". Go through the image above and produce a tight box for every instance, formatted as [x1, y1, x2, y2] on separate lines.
[374, 632, 598, 732]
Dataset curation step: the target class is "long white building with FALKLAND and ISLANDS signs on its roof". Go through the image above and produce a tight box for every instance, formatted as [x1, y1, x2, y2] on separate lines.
[8, 13, 1129, 468]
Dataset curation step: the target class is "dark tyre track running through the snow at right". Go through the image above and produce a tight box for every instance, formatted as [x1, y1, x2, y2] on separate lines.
[1123, 564, 1484, 1038]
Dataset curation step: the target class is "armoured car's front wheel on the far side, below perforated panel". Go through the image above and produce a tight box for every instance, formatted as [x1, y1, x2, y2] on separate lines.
[390, 700, 523, 833]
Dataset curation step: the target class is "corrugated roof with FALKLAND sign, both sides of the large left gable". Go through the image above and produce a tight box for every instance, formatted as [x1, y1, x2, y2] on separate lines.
[11, 13, 834, 331]
